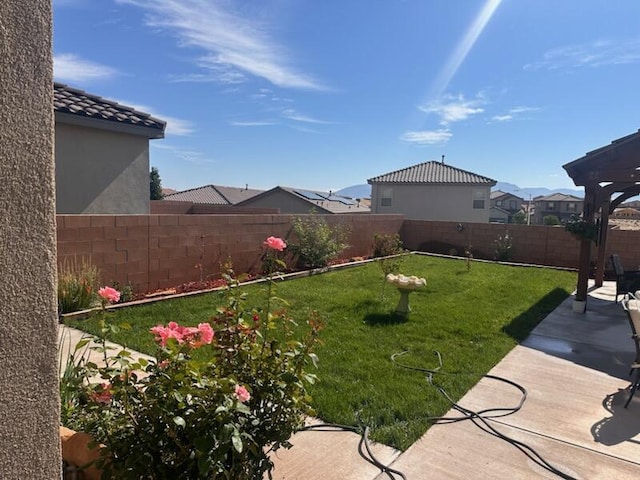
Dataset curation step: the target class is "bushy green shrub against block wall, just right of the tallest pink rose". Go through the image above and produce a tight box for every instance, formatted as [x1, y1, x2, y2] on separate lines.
[289, 215, 349, 269]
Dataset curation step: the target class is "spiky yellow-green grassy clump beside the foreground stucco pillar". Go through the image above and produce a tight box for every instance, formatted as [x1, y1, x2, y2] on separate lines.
[58, 260, 98, 313]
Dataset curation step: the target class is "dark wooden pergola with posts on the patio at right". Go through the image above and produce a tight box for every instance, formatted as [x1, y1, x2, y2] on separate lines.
[562, 130, 640, 308]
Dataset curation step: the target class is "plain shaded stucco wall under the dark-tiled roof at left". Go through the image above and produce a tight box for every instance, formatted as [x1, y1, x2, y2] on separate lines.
[55, 119, 149, 214]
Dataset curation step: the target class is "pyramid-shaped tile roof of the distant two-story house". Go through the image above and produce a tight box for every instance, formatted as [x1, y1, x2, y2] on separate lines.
[367, 161, 497, 185]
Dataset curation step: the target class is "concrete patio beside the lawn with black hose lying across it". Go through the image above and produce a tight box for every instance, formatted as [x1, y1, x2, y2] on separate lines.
[61, 282, 640, 480]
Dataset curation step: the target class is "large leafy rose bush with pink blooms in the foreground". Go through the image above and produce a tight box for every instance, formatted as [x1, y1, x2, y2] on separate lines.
[62, 237, 320, 480]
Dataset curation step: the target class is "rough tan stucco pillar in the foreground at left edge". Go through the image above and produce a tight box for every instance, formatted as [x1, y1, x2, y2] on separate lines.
[0, 0, 61, 480]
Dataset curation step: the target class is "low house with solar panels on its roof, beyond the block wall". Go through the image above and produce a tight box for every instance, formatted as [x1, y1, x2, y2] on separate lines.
[237, 187, 370, 214]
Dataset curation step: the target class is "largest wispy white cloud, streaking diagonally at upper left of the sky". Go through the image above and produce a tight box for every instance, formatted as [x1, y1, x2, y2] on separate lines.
[116, 0, 326, 90]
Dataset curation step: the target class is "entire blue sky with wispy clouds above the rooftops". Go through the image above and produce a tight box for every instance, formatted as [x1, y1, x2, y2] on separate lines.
[53, 0, 640, 191]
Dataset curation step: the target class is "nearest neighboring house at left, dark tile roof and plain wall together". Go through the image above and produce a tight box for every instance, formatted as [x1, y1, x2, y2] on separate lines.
[53, 83, 166, 214]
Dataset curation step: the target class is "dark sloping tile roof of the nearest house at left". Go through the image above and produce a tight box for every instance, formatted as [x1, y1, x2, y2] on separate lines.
[53, 82, 166, 138]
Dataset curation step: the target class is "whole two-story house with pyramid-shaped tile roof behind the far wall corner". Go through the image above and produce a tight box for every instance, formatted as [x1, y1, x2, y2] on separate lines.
[367, 161, 496, 223]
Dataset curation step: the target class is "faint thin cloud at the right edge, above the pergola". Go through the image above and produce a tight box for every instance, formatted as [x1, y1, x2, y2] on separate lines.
[524, 38, 640, 70]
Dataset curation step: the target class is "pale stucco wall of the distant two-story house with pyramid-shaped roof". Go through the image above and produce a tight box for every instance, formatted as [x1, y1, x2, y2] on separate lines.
[371, 184, 491, 223]
